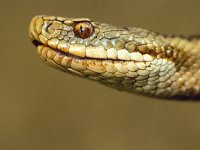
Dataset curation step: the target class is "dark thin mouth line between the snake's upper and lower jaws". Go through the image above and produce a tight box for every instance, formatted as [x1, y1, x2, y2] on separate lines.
[32, 40, 128, 62]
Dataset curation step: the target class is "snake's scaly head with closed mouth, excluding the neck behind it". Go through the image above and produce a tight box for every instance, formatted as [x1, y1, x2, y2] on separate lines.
[29, 16, 184, 95]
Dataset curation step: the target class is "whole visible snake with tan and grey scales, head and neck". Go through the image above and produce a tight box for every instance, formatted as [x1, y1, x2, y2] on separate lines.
[29, 15, 200, 99]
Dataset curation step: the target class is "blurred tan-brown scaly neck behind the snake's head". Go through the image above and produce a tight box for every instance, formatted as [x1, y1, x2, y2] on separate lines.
[166, 37, 200, 98]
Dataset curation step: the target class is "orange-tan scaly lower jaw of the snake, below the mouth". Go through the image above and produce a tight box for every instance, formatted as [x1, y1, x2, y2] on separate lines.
[37, 45, 135, 80]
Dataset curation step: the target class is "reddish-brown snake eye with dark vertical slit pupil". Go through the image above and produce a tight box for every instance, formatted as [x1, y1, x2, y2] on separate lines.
[74, 22, 93, 39]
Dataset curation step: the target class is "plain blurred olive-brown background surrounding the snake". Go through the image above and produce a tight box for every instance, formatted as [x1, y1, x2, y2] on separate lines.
[0, 0, 200, 150]
